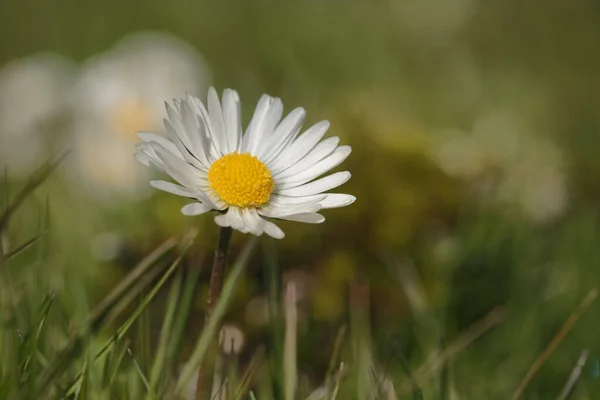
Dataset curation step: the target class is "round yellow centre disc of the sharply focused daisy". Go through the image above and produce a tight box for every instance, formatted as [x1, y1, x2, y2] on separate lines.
[208, 152, 275, 208]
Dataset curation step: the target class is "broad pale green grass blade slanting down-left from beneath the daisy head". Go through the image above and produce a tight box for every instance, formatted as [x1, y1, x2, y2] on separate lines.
[174, 237, 256, 393]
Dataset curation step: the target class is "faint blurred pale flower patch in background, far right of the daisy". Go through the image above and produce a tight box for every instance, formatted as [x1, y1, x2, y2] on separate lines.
[432, 112, 568, 222]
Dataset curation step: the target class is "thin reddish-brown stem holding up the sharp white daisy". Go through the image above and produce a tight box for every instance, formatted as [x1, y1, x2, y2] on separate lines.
[196, 227, 233, 400]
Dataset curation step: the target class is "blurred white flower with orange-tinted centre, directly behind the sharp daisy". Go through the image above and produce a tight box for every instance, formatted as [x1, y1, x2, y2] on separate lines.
[72, 33, 210, 199]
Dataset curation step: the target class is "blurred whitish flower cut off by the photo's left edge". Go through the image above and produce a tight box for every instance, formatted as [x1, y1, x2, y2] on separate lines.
[0, 54, 73, 177]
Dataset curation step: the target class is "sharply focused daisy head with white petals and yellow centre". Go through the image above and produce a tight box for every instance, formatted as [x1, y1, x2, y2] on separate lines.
[135, 88, 355, 239]
